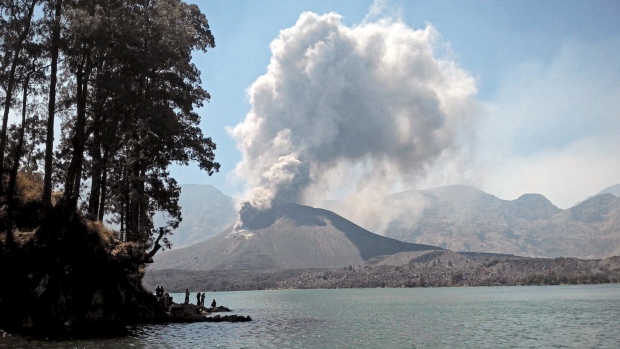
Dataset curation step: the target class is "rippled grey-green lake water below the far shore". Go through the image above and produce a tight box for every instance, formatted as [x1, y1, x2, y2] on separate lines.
[0, 284, 620, 349]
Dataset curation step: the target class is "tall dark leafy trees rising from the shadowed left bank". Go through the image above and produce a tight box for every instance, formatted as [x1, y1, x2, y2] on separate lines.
[0, 0, 219, 254]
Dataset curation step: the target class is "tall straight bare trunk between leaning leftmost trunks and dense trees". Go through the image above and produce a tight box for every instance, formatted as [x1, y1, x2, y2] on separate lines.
[42, 0, 62, 212]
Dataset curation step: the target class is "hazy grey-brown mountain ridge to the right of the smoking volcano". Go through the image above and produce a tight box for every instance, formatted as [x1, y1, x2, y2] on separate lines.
[384, 186, 620, 258]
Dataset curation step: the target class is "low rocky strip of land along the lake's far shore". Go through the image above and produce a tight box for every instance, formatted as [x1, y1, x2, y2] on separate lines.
[143, 251, 620, 292]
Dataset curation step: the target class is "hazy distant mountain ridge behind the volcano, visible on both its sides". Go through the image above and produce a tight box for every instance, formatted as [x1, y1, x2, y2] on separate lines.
[159, 185, 620, 258]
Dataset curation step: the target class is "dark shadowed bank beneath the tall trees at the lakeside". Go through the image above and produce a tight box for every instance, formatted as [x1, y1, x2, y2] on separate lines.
[0, 205, 164, 337]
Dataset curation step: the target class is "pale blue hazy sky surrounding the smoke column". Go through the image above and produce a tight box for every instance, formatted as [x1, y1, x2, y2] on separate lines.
[172, 0, 620, 208]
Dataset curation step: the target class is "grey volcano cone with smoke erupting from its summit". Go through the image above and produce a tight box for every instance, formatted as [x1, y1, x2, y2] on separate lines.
[149, 204, 440, 270]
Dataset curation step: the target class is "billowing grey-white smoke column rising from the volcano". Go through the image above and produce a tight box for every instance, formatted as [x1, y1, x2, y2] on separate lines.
[229, 12, 476, 228]
